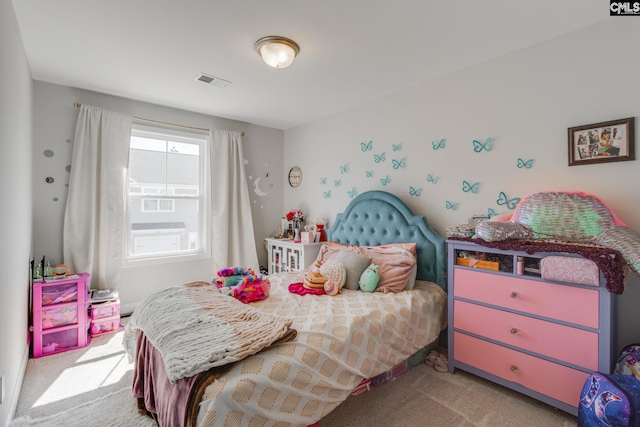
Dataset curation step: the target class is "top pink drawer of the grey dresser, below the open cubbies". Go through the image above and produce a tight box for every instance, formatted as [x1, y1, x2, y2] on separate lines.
[454, 268, 599, 329]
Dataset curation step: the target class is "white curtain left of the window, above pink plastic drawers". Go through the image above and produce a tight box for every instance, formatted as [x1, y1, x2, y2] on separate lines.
[63, 105, 132, 289]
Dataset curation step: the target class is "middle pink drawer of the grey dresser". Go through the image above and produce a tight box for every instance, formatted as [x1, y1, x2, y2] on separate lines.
[453, 301, 598, 371]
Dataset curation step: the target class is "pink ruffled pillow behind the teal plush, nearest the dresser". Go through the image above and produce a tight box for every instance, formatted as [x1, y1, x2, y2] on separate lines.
[359, 243, 417, 293]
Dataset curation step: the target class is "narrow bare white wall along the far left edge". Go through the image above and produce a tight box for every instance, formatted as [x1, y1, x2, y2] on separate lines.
[0, 0, 33, 425]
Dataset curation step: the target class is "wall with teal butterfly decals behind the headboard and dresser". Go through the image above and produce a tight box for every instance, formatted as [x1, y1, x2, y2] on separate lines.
[284, 17, 640, 354]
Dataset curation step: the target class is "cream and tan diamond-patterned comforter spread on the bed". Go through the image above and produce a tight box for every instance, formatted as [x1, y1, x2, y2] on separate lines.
[198, 273, 447, 427]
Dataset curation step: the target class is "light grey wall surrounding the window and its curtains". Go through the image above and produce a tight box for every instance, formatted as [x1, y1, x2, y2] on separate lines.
[33, 81, 284, 313]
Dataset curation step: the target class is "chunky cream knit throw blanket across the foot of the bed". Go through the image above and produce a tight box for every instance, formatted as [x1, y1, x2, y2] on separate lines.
[123, 282, 296, 383]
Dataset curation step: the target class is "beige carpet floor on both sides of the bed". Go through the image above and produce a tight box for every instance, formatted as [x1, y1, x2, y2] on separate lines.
[12, 319, 577, 427]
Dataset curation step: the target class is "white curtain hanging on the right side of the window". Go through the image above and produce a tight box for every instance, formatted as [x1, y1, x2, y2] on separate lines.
[211, 130, 259, 273]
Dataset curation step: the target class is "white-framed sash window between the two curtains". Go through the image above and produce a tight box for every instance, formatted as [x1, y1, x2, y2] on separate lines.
[125, 124, 209, 262]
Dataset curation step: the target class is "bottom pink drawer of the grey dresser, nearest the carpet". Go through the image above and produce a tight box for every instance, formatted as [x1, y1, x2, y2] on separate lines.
[454, 332, 589, 407]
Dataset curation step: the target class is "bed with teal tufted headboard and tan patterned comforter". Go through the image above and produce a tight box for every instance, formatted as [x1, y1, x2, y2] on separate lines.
[124, 191, 447, 426]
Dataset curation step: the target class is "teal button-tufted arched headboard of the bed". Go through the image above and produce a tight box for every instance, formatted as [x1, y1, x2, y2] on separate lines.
[327, 191, 447, 291]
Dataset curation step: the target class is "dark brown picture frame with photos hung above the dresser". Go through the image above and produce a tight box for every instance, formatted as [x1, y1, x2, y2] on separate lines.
[568, 117, 635, 166]
